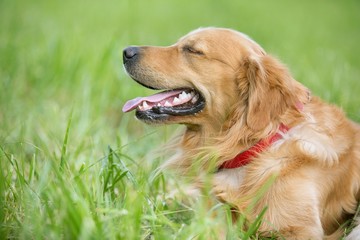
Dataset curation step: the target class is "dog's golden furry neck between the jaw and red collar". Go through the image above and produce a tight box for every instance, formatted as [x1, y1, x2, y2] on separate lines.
[172, 98, 306, 172]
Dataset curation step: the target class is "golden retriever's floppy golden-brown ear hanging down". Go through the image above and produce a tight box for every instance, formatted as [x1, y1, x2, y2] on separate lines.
[240, 55, 308, 130]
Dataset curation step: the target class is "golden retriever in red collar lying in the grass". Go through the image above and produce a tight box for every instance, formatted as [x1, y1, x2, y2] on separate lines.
[123, 28, 360, 239]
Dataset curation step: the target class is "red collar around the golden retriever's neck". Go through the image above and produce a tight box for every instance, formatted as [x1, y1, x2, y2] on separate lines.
[218, 124, 289, 170]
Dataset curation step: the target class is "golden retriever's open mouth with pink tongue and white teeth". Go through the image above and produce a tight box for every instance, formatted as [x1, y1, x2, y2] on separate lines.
[122, 89, 205, 121]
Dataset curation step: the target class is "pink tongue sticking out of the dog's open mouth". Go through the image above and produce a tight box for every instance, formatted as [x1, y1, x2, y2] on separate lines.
[122, 90, 183, 112]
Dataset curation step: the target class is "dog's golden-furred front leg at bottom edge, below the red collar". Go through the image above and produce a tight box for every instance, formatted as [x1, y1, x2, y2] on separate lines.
[237, 177, 324, 239]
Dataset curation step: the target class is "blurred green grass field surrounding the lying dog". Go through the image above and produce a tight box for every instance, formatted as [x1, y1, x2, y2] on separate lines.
[0, 0, 360, 239]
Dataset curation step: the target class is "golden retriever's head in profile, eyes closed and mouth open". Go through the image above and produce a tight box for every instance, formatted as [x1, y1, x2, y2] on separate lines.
[123, 28, 306, 132]
